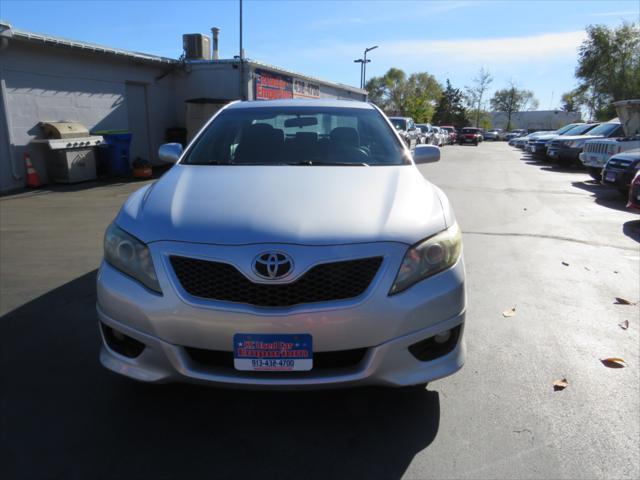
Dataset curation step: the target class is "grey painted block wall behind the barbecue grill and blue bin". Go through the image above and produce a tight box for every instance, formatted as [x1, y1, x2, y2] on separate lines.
[0, 40, 177, 191]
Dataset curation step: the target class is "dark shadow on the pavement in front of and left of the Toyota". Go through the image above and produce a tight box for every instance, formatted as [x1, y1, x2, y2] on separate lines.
[0, 271, 440, 479]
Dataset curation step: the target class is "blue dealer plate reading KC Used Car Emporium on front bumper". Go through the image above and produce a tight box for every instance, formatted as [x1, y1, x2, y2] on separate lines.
[233, 333, 313, 372]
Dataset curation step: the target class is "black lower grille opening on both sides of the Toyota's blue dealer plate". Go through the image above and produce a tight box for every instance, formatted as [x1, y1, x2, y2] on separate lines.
[184, 347, 367, 373]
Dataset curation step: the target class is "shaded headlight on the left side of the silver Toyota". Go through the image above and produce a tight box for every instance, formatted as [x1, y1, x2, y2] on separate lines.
[104, 223, 162, 293]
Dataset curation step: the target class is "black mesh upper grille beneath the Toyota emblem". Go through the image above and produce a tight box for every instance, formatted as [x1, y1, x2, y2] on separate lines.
[171, 256, 382, 307]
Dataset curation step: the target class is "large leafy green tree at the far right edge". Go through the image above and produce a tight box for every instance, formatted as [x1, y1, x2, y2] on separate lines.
[573, 23, 640, 120]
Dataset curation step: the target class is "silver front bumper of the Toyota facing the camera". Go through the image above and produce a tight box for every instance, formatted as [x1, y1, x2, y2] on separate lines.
[97, 242, 465, 388]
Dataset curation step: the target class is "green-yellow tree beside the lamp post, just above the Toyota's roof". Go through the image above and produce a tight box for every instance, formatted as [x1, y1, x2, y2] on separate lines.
[365, 68, 442, 123]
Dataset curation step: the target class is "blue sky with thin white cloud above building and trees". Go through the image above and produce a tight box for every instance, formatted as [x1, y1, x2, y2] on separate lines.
[0, 0, 640, 109]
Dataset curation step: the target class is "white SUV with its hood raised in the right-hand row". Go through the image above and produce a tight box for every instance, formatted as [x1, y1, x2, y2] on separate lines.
[579, 100, 640, 181]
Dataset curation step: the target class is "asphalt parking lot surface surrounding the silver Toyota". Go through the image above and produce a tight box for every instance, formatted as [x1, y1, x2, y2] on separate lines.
[0, 142, 640, 479]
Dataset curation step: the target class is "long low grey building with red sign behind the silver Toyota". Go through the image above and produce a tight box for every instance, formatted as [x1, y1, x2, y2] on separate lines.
[0, 23, 366, 191]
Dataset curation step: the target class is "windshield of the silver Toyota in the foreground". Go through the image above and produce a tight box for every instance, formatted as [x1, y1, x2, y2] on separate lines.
[181, 106, 410, 165]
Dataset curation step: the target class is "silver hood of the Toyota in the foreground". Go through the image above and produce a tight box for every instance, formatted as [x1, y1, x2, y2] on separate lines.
[116, 164, 447, 245]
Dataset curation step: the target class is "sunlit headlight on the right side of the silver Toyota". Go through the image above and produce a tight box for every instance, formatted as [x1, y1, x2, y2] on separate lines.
[389, 223, 462, 295]
